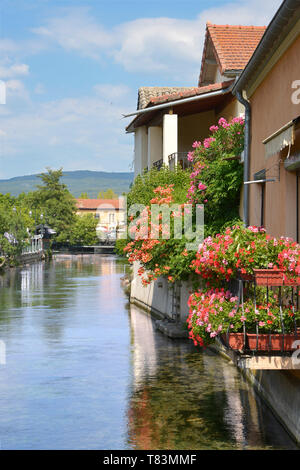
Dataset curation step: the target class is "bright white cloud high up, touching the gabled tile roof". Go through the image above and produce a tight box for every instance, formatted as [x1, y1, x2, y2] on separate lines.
[29, 0, 281, 83]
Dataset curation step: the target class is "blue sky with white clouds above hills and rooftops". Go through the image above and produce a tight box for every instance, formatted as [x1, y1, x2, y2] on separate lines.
[0, 0, 281, 178]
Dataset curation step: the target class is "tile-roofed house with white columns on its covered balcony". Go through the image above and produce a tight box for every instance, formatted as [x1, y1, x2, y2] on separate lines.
[126, 23, 266, 176]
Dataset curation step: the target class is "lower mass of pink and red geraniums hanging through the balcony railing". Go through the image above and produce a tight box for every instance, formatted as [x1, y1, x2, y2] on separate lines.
[187, 288, 300, 346]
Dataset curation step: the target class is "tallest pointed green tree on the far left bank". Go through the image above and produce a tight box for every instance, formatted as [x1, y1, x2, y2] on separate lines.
[33, 168, 76, 242]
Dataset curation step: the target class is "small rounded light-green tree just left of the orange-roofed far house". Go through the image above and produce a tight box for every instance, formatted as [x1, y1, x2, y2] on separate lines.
[70, 214, 99, 245]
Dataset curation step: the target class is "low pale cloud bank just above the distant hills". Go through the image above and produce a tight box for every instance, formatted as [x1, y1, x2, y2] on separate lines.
[0, 84, 132, 177]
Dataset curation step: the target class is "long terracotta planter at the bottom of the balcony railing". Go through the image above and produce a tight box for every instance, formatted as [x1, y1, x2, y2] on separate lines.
[247, 333, 300, 351]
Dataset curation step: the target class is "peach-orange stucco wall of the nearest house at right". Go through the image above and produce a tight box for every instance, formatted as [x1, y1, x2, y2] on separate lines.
[249, 36, 300, 238]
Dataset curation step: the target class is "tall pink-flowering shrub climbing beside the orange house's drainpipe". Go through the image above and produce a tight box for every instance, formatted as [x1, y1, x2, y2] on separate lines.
[187, 118, 244, 233]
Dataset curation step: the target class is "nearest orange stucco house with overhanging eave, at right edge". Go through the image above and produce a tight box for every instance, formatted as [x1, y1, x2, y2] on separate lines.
[234, 0, 300, 241]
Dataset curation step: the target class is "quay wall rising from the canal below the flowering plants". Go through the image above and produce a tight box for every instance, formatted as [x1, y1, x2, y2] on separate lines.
[130, 263, 300, 445]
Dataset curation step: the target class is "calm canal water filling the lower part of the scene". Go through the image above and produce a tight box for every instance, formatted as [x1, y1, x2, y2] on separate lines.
[0, 255, 295, 450]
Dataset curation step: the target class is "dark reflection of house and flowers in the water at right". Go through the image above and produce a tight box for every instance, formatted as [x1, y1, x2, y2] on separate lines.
[128, 306, 295, 450]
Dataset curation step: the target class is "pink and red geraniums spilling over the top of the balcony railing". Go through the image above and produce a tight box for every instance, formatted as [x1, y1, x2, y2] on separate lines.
[191, 226, 300, 282]
